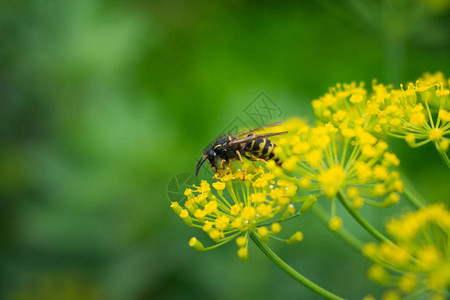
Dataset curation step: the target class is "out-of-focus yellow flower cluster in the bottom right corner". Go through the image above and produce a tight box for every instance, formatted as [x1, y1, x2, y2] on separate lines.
[363, 203, 450, 299]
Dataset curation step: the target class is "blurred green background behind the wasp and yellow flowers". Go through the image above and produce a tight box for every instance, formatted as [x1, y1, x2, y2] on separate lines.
[0, 0, 450, 300]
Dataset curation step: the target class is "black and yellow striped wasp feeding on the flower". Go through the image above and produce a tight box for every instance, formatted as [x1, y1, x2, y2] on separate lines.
[195, 123, 287, 180]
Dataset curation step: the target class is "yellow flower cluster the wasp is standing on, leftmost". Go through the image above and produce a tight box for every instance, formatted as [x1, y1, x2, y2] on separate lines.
[171, 167, 306, 260]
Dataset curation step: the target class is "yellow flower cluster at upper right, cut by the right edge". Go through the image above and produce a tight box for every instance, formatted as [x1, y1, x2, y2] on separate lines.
[312, 73, 450, 167]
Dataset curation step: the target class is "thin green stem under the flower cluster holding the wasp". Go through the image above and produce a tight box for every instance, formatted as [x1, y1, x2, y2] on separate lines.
[250, 231, 343, 300]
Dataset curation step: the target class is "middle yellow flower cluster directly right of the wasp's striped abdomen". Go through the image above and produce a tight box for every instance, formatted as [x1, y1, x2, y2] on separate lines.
[267, 120, 403, 211]
